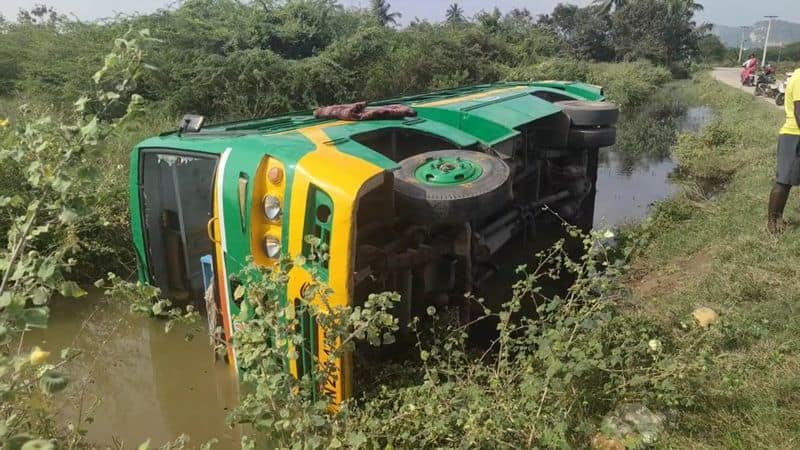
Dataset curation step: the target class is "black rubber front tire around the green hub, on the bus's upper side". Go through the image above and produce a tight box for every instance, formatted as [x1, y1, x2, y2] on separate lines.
[394, 150, 512, 224]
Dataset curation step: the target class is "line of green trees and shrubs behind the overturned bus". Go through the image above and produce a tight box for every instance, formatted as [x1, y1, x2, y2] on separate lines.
[0, 0, 708, 117]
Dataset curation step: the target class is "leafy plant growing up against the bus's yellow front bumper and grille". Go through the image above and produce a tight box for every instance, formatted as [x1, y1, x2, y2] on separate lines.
[230, 237, 399, 448]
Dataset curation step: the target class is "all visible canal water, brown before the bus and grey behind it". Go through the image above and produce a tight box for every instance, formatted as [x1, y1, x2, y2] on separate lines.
[24, 104, 710, 449]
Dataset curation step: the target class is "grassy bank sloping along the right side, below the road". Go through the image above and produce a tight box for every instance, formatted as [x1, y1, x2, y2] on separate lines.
[629, 75, 800, 448]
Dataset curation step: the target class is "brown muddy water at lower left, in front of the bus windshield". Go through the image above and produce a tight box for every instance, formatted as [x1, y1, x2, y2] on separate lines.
[24, 292, 240, 448]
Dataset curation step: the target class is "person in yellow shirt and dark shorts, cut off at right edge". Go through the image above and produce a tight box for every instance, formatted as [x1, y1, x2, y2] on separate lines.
[767, 69, 800, 233]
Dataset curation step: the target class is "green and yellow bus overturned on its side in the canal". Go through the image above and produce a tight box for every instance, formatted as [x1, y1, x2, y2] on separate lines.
[130, 82, 618, 401]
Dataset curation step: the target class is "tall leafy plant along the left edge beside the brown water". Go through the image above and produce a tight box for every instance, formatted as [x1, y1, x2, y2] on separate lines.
[0, 30, 152, 448]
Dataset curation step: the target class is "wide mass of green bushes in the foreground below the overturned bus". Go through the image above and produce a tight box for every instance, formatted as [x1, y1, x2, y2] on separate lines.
[227, 229, 708, 449]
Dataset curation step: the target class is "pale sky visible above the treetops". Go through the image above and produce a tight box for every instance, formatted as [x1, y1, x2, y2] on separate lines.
[0, 0, 800, 26]
